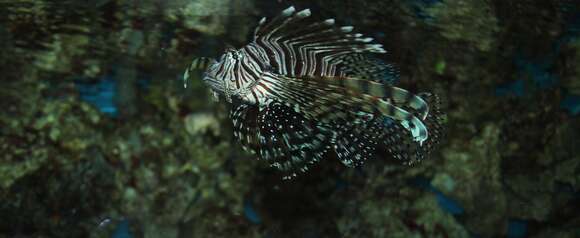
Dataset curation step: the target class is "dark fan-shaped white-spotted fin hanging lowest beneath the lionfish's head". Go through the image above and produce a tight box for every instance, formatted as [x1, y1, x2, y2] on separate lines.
[230, 101, 332, 179]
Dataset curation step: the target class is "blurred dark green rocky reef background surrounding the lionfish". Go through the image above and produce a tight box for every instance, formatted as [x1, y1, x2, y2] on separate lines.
[0, 0, 580, 238]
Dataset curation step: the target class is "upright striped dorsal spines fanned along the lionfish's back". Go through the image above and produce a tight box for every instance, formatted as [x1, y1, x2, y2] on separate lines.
[254, 7, 385, 76]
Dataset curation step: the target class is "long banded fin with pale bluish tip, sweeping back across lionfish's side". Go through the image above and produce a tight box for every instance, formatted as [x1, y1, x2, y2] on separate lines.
[264, 74, 428, 142]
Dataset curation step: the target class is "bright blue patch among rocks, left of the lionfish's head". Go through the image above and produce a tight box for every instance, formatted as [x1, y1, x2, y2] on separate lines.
[75, 77, 118, 117]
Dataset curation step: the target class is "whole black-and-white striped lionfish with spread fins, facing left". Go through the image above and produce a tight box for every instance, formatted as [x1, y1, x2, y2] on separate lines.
[183, 7, 442, 179]
